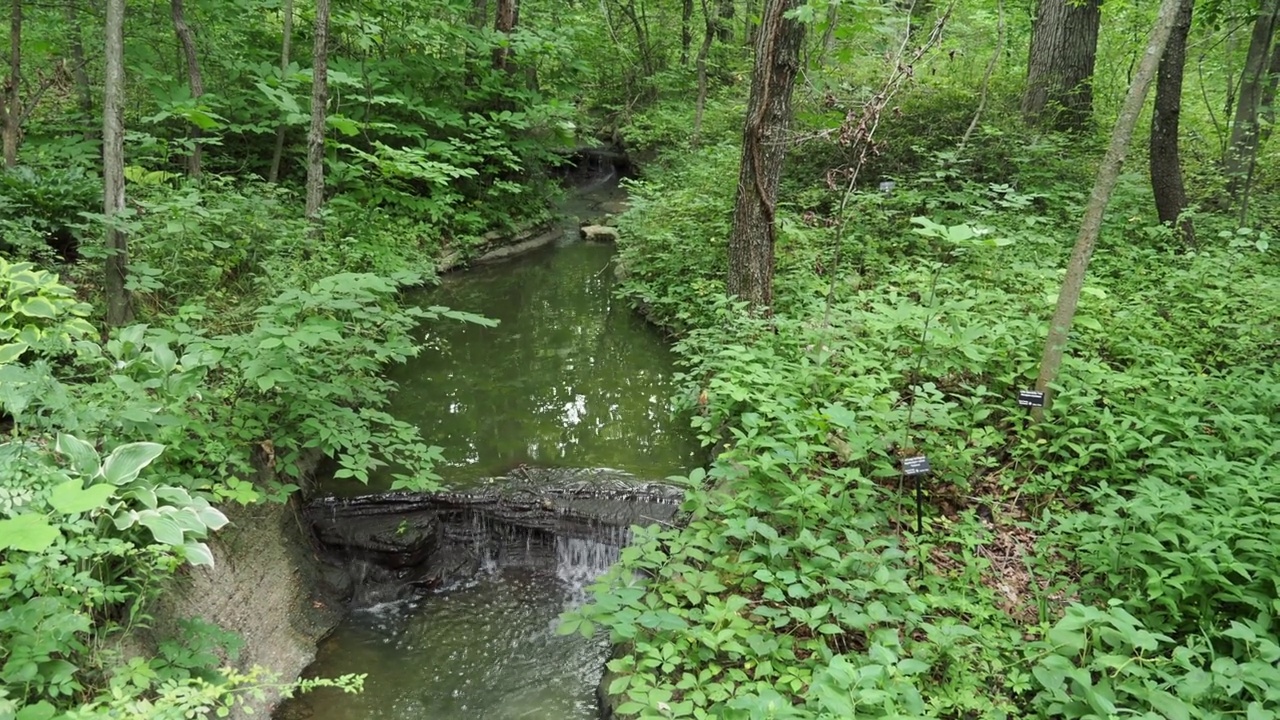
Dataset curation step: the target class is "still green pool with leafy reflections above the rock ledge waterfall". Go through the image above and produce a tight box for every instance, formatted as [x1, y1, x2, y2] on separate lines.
[333, 238, 696, 492]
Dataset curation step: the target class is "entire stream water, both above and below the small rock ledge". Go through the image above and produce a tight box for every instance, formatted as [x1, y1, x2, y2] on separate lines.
[278, 174, 703, 720]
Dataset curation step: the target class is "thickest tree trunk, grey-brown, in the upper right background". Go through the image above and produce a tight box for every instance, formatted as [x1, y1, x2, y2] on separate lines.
[1023, 0, 1102, 129]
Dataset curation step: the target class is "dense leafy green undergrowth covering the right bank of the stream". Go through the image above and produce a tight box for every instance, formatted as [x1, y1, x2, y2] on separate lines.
[564, 96, 1280, 720]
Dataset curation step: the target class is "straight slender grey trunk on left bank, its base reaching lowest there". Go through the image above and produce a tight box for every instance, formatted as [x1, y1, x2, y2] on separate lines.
[102, 0, 133, 327]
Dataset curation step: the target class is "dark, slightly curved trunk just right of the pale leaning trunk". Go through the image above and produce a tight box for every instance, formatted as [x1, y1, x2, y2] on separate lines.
[1148, 0, 1196, 246]
